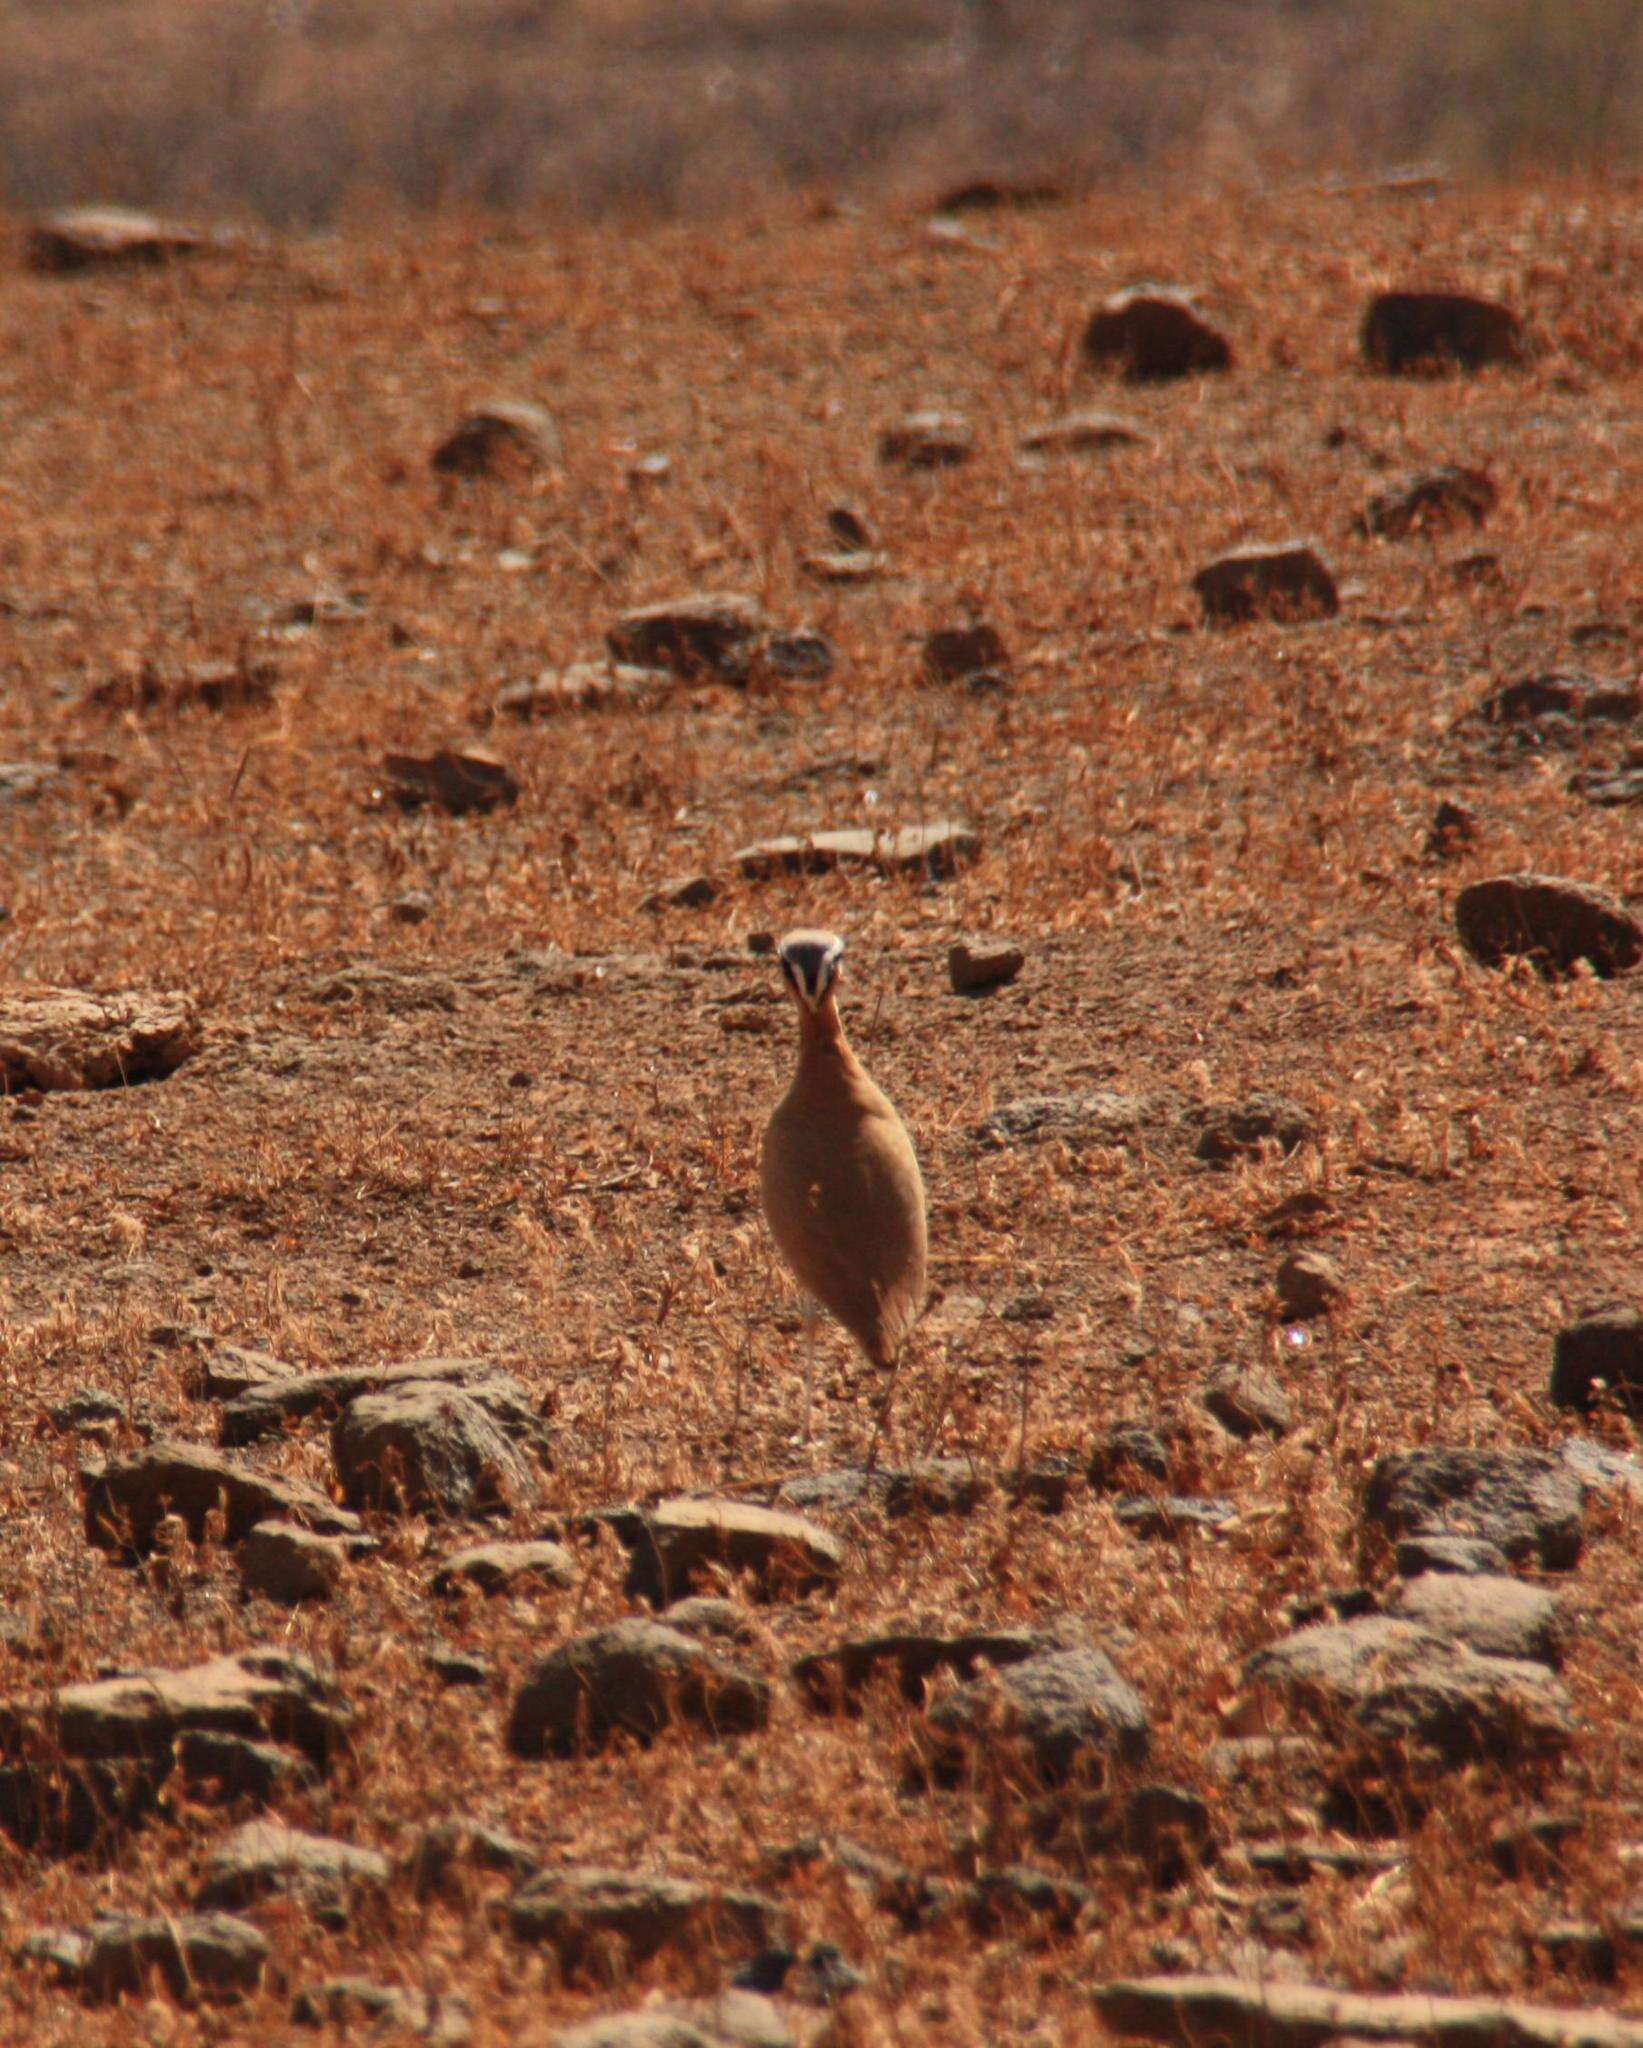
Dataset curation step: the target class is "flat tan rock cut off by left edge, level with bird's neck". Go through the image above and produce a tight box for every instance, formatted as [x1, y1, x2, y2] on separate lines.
[0, 989, 201, 1096]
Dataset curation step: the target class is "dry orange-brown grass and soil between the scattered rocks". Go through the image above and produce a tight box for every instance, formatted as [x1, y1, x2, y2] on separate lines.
[0, 167, 1643, 2044]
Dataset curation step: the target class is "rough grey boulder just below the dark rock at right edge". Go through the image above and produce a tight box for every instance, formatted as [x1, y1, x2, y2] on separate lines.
[1364, 1446, 1584, 1571]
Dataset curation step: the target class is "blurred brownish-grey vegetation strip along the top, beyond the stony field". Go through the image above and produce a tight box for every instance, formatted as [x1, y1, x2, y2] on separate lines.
[0, 0, 1643, 223]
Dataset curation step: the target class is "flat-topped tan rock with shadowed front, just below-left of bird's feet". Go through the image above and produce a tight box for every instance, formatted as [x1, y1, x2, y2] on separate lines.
[602, 1497, 844, 1604]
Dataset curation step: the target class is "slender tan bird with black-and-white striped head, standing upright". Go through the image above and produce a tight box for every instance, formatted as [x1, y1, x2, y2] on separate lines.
[760, 930, 928, 1442]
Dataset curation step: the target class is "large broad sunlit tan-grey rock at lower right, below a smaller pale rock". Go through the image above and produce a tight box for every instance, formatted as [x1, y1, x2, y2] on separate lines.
[1244, 1622, 1573, 1767]
